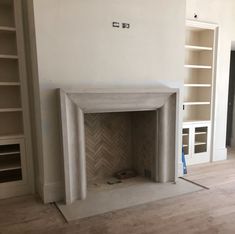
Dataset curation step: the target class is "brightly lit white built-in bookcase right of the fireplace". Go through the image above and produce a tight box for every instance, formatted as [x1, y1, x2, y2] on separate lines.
[182, 21, 217, 165]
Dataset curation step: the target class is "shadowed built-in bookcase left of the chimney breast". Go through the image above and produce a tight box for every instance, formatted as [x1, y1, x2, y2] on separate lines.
[0, 0, 33, 199]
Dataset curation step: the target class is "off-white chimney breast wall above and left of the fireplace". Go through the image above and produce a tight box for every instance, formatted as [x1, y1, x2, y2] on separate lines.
[34, 0, 185, 202]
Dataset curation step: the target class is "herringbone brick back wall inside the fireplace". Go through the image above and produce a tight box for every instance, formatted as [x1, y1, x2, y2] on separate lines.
[85, 113, 133, 181]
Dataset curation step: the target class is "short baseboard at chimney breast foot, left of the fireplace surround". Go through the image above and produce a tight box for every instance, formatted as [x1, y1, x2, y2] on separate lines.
[43, 182, 65, 203]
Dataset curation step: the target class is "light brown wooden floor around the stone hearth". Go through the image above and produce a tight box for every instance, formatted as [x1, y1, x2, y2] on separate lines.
[0, 154, 235, 234]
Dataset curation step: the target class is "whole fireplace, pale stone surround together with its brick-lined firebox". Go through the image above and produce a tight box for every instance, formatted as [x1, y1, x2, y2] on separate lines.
[59, 88, 179, 204]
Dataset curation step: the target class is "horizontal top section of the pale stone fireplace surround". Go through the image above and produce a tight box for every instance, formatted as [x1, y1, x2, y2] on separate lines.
[58, 87, 179, 113]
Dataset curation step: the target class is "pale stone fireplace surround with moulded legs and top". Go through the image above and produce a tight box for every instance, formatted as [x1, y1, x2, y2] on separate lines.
[58, 87, 180, 204]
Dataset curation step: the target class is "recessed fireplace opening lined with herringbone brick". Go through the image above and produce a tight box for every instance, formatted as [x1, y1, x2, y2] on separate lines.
[84, 111, 157, 190]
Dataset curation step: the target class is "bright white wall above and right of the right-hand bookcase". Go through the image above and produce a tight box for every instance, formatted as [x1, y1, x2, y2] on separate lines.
[186, 0, 235, 160]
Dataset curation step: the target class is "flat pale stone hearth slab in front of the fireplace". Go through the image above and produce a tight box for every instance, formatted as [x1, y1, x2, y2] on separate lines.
[57, 179, 203, 222]
